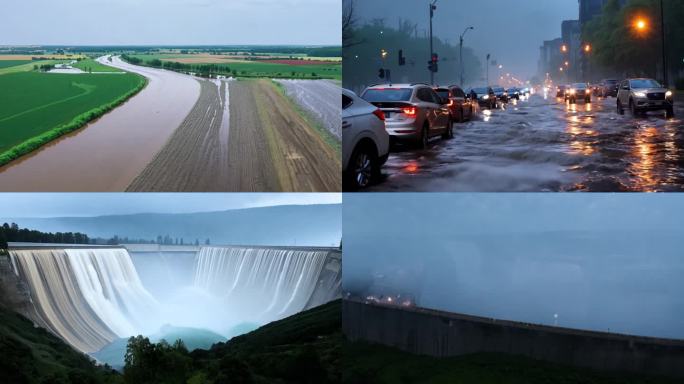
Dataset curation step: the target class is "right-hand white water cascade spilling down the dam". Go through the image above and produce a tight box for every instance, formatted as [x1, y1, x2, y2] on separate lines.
[194, 247, 328, 322]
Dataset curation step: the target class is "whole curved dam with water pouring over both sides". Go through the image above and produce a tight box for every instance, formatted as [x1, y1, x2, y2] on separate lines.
[2, 243, 341, 353]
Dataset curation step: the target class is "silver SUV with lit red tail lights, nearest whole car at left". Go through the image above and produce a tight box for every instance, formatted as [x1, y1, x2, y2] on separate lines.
[361, 84, 454, 148]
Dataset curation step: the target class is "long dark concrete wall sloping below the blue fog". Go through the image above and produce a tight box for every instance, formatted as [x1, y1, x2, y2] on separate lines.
[342, 300, 684, 377]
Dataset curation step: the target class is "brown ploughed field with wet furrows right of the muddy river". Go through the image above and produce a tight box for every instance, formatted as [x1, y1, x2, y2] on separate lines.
[128, 80, 341, 192]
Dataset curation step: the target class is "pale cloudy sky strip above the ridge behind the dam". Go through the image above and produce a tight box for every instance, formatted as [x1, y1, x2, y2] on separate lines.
[0, 193, 342, 219]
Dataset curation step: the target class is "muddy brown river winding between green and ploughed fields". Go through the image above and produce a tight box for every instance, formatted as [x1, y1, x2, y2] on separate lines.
[0, 57, 200, 191]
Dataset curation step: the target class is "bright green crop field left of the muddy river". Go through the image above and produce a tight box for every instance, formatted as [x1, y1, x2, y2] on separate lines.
[0, 72, 145, 165]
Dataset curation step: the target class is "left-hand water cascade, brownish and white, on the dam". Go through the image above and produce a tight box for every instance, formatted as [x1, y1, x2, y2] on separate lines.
[10, 248, 159, 352]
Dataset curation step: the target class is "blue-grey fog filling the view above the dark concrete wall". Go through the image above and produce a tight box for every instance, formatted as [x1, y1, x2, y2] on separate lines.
[343, 194, 684, 338]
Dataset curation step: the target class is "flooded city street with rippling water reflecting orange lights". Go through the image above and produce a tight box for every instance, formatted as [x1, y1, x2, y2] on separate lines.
[369, 95, 684, 192]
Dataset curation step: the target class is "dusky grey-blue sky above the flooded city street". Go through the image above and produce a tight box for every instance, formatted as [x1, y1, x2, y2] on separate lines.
[355, 0, 579, 80]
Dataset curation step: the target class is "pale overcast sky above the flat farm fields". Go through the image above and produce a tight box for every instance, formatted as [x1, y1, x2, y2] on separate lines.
[0, 0, 342, 45]
